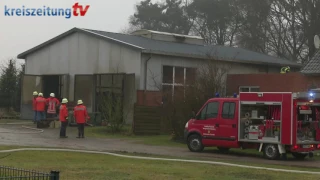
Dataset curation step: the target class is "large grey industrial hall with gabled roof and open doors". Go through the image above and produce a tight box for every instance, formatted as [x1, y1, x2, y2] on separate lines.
[18, 28, 300, 123]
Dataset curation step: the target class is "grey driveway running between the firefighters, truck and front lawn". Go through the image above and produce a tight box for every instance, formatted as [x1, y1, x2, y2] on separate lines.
[0, 125, 320, 168]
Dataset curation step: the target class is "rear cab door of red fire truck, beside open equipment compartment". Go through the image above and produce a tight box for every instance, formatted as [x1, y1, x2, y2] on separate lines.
[215, 101, 238, 143]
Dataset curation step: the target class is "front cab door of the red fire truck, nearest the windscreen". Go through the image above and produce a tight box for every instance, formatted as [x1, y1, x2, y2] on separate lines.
[194, 101, 220, 145]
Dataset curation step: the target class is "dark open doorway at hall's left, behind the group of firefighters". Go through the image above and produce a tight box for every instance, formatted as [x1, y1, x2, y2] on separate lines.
[42, 75, 61, 101]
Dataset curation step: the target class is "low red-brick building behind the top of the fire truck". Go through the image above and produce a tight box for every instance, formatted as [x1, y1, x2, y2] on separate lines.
[227, 50, 320, 94]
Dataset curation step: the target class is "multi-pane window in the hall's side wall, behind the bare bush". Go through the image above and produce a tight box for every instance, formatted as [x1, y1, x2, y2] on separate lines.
[162, 66, 196, 98]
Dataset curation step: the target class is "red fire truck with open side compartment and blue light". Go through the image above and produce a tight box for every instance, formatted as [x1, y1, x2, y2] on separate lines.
[185, 92, 320, 159]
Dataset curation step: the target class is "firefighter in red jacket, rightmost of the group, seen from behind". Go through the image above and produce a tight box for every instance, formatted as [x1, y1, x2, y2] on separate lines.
[73, 100, 90, 138]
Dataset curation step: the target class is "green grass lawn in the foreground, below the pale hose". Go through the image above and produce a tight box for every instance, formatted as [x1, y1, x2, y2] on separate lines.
[0, 151, 320, 180]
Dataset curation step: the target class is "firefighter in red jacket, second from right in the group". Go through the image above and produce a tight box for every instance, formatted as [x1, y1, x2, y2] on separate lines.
[59, 98, 69, 138]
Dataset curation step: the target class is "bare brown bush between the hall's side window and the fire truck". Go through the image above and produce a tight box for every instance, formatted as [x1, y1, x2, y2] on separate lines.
[149, 50, 232, 140]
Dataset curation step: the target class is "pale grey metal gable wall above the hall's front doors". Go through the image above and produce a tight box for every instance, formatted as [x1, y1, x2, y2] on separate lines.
[21, 33, 141, 119]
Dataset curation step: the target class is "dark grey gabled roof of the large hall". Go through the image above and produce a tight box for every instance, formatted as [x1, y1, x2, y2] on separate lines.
[18, 28, 302, 67]
